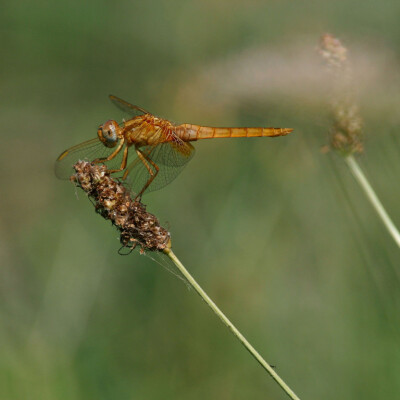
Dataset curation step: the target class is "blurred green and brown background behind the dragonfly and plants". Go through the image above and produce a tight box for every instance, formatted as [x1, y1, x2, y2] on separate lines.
[0, 0, 400, 400]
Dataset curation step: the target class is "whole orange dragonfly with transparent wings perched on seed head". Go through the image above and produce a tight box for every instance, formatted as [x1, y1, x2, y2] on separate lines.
[55, 96, 292, 199]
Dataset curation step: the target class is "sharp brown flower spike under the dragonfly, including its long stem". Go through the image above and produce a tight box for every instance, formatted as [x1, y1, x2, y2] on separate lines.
[71, 166, 300, 400]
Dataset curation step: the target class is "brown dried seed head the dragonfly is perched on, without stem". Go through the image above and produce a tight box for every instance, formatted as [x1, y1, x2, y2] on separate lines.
[71, 161, 171, 251]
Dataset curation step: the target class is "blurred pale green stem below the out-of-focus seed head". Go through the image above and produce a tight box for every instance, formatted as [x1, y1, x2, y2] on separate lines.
[344, 155, 400, 247]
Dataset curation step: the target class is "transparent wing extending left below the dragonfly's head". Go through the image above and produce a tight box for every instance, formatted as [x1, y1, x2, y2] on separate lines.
[55, 138, 123, 179]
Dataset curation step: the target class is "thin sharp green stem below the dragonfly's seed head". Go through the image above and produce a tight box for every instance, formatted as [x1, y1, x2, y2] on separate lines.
[164, 248, 300, 400]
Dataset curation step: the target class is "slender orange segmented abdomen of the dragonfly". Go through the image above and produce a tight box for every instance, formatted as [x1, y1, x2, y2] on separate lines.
[176, 124, 292, 141]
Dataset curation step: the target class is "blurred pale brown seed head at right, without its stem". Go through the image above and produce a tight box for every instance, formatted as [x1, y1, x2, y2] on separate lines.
[318, 34, 363, 155]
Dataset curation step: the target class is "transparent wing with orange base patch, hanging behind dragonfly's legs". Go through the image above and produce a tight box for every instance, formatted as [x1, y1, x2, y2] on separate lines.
[126, 139, 195, 195]
